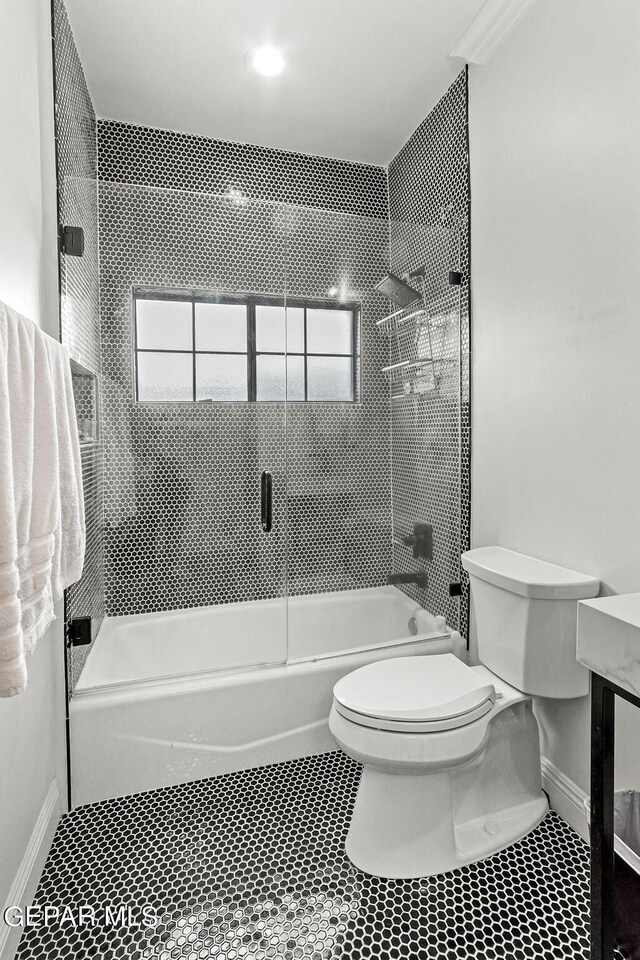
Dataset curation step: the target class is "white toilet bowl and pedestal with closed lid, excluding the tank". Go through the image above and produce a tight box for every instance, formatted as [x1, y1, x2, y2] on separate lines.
[329, 654, 547, 879]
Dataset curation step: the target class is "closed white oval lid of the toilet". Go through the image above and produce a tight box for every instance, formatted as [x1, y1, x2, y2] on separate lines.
[333, 653, 495, 723]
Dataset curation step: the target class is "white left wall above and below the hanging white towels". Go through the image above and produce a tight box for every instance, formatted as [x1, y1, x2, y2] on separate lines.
[0, 0, 65, 951]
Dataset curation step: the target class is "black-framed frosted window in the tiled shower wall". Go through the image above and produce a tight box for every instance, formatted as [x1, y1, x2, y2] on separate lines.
[134, 290, 358, 402]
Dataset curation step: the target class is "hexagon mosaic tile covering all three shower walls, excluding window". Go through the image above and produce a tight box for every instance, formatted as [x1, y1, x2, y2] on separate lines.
[56, 0, 476, 644]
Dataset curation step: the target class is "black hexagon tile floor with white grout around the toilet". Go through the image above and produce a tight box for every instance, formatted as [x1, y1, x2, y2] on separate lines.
[18, 753, 608, 960]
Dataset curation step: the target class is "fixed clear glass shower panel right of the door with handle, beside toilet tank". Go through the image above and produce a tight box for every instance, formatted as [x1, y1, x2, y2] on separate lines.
[286, 207, 461, 661]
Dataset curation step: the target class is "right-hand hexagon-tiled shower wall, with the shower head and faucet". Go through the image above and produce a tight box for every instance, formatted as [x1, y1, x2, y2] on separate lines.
[389, 71, 471, 636]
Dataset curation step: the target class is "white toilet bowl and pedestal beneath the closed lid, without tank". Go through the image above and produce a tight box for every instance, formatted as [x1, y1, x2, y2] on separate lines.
[336, 684, 549, 880]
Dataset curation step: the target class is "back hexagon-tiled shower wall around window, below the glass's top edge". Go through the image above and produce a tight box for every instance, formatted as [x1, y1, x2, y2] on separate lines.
[100, 174, 391, 615]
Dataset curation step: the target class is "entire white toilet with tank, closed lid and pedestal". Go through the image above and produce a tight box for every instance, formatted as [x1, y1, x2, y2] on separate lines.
[329, 547, 600, 879]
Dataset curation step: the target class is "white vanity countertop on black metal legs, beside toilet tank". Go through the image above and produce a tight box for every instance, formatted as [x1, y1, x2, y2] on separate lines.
[576, 593, 640, 697]
